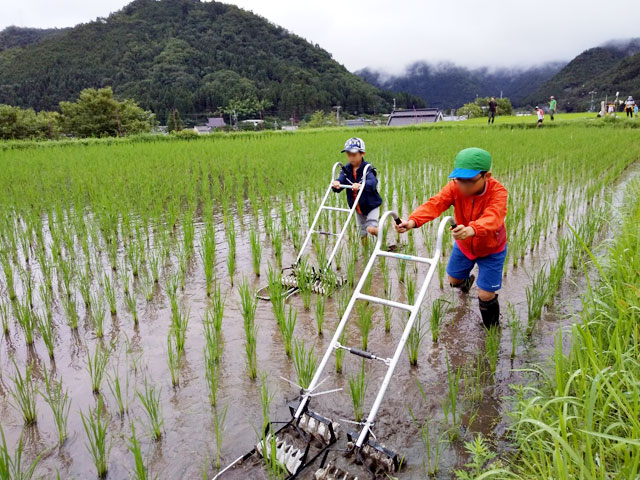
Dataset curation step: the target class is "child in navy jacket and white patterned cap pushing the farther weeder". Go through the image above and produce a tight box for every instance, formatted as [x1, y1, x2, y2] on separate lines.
[331, 137, 382, 239]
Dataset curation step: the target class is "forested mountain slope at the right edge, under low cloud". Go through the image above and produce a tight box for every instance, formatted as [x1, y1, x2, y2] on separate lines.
[525, 38, 640, 111]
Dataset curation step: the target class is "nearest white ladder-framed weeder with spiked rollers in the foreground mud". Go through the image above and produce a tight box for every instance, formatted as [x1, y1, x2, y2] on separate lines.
[214, 211, 455, 480]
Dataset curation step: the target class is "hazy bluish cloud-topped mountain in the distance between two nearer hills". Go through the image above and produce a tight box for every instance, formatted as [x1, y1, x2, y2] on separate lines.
[356, 62, 564, 108]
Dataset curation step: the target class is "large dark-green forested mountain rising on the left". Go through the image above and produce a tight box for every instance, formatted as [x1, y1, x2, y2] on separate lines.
[0, 0, 424, 122]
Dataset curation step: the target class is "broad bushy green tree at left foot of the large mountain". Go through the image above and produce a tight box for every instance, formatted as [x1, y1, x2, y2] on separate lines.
[60, 87, 154, 137]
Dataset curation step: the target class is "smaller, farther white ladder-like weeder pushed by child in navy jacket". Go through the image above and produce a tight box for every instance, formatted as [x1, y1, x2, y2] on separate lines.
[258, 162, 371, 300]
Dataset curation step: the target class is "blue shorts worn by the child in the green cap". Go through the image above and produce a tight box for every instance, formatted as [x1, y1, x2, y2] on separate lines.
[447, 243, 507, 292]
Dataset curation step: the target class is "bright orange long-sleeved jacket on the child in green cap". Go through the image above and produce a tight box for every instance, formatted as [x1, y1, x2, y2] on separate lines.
[409, 177, 509, 260]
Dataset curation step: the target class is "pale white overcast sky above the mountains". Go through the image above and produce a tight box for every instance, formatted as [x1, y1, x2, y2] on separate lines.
[5, 0, 640, 72]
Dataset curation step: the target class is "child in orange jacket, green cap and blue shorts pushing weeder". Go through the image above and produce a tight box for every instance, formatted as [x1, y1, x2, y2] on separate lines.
[396, 148, 509, 328]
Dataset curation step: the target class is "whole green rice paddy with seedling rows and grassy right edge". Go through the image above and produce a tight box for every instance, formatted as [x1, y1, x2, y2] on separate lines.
[0, 122, 640, 479]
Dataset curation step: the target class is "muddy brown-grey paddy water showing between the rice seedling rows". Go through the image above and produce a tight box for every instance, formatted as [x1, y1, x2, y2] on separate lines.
[0, 125, 637, 479]
